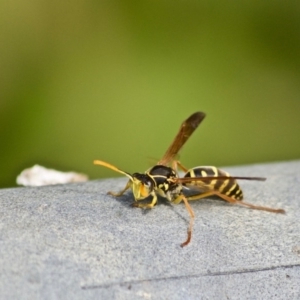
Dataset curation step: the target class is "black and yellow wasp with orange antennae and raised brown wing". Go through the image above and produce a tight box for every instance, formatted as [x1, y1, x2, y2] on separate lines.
[94, 112, 285, 247]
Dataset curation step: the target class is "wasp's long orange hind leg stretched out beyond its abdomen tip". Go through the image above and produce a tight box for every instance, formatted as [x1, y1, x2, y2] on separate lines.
[187, 191, 285, 214]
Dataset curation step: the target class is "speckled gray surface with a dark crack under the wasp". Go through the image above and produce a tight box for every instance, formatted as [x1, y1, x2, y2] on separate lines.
[0, 161, 300, 299]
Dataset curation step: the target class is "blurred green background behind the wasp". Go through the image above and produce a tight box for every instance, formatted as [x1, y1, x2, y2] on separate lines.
[0, 0, 300, 187]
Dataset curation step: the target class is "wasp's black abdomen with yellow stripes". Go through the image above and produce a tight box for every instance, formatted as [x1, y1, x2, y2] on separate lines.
[184, 167, 243, 200]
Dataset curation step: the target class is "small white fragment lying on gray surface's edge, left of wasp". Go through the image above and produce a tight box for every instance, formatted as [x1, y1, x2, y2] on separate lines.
[17, 165, 88, 186]
